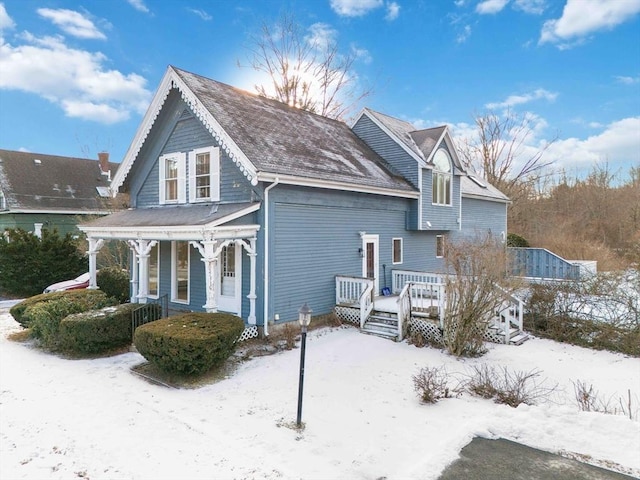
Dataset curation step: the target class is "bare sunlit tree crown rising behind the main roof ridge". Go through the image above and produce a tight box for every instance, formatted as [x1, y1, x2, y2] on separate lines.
[239, 14, 371, 120]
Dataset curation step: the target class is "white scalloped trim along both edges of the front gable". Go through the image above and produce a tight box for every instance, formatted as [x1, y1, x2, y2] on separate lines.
[112, 66, 258, 196]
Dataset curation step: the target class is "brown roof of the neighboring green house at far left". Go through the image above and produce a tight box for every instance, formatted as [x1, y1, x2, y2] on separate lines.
[0, 150, 116, 214]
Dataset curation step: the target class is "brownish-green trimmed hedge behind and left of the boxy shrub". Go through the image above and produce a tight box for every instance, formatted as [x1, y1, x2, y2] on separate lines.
[22, 290, 114, 349]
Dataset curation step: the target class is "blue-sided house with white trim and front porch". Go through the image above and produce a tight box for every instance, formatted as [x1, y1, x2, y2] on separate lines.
[81, 66, 508, 335]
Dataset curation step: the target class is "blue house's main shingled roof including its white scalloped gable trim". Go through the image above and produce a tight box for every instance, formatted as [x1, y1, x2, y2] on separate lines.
[113, 66, 418, 197]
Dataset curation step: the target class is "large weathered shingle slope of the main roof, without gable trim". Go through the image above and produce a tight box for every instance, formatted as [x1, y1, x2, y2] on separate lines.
[172, 67, 415, 192]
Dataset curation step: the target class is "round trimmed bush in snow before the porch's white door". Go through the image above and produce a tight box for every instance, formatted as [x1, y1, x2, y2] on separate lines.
[133, 313, 244, 375]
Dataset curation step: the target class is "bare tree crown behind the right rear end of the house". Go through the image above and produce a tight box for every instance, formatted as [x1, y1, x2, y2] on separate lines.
[458, 110, 558, 201]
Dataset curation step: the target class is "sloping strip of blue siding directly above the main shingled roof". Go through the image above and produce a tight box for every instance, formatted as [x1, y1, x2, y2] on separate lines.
[352, 115, 419, 188]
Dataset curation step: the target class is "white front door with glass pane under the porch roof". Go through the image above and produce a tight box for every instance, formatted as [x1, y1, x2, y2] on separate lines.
[216, 243, 242, 316]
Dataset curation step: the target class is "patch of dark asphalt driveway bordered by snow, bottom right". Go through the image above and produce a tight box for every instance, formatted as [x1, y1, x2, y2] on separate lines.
[438, 437, 636, 480]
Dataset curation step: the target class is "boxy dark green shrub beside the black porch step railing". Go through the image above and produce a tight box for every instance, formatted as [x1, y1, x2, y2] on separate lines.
[58, 303, 140, 354]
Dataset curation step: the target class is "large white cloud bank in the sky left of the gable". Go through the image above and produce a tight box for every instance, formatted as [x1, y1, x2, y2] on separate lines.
[0, 26, 151, 124]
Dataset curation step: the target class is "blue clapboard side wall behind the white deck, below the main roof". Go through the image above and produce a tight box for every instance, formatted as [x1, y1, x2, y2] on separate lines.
[268, 186, 443, 321]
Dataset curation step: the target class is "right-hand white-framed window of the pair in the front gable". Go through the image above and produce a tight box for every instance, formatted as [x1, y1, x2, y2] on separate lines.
[189, 147, 220, 202]
